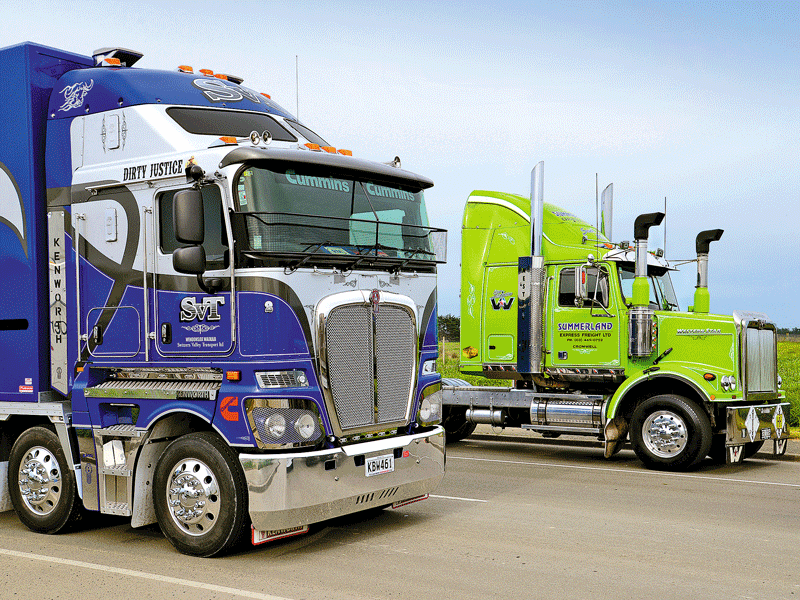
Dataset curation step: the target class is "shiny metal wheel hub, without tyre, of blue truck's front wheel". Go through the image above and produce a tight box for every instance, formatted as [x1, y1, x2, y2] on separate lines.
[167, 459, 220, 535]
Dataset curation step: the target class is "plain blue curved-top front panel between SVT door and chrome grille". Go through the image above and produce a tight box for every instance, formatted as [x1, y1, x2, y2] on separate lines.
[237, 292, 308, 356]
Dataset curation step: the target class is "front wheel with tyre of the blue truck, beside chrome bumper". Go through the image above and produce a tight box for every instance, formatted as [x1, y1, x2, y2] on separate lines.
[153, 432, 249, 557]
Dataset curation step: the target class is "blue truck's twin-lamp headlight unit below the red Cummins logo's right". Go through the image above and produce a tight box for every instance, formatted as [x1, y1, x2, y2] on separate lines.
[244, 398, 324, 450]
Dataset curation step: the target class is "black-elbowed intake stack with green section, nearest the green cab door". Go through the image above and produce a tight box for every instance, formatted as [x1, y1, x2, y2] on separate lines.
[628, 213, 664, 358]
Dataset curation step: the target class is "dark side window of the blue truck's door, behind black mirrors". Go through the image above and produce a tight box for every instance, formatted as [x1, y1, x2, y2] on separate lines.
[158, 185, 228, 271]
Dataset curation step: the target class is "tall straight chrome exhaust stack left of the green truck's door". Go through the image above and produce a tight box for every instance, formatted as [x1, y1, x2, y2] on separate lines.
[517, 162, 545, 373]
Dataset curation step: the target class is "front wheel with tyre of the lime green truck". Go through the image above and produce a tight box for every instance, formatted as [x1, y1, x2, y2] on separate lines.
[630, 394, 712, 471]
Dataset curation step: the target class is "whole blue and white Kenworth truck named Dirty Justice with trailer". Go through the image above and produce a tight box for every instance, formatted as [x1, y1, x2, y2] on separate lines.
[0, 43, 446, 556]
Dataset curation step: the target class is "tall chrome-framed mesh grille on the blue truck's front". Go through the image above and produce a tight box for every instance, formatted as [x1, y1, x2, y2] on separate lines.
[325, 303, 417, 432]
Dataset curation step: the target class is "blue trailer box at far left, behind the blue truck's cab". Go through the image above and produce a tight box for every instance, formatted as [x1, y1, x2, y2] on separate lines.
[0, 43, 89, 401]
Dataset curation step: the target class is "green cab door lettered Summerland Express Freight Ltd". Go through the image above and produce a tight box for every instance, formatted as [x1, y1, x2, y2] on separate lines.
[547, 263, 621, 375]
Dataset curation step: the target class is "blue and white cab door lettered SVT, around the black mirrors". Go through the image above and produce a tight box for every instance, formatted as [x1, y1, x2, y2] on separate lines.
[153, 185, 235, 356]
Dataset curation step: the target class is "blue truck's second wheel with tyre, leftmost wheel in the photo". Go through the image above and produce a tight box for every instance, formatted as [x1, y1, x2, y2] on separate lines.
[8, 427, 83, 533]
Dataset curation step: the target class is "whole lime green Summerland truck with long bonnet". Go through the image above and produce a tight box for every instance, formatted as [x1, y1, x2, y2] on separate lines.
[444, 163, 789, 470]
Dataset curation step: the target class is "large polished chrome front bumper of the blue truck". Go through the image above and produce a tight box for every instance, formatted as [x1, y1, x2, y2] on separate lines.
[239, 427, 445, 531]
